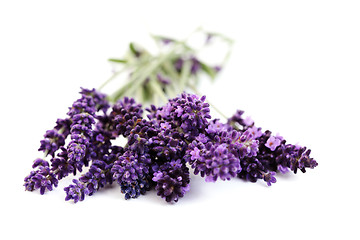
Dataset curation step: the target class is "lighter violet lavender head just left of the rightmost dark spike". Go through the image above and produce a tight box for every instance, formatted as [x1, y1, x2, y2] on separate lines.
[185, 119, 258, 182]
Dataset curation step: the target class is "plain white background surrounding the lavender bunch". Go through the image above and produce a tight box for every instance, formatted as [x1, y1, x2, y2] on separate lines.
[0, 0, 360, 239]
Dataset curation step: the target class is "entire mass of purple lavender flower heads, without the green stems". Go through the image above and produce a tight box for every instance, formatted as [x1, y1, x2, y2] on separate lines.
[24, 87, 317, 203]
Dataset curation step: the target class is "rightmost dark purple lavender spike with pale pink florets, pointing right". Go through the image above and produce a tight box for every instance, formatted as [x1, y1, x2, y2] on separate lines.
[228, 110, 317, 186]
